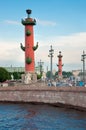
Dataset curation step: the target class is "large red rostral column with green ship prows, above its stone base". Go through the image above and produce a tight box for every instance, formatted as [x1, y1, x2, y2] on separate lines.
[21, 9, 38, 72]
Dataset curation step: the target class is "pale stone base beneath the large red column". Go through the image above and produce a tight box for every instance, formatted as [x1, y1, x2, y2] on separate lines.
[22, 72, 37, 84]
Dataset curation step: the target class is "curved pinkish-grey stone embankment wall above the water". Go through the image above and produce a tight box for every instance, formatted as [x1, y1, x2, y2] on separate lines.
[0, 84, 86, 111]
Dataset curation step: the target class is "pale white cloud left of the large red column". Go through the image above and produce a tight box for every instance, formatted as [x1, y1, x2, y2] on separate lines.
[0, 41, 24, 66]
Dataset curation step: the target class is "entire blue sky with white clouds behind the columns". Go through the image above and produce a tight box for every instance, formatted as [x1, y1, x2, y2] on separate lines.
[0, 0, 86, 71]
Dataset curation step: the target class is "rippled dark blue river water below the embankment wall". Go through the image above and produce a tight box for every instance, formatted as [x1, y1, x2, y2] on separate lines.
[0, 103, 86, 130]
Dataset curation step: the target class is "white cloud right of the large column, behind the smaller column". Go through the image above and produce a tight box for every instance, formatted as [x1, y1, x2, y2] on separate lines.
[36, 32, 86, 70]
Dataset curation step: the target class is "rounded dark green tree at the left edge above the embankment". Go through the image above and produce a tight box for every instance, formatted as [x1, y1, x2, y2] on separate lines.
[0, 67, 11, 82]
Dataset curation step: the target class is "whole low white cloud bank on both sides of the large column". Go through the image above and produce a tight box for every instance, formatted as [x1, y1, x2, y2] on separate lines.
[0, 32, 86, 70]
